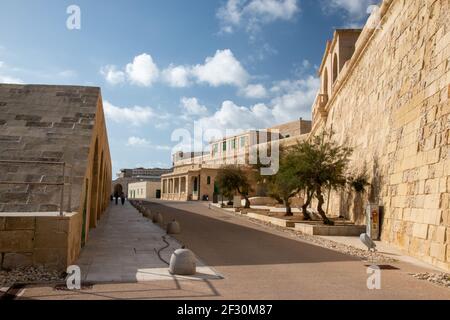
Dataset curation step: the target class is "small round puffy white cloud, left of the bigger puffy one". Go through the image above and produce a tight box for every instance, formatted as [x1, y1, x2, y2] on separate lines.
[125, 53, 159, 87]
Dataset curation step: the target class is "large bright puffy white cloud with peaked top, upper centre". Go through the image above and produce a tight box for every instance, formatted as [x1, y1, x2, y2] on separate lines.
[192, 49, 249, 87]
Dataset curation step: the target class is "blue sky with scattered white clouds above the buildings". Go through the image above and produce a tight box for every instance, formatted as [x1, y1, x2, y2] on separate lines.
[0, 0, 378, 176]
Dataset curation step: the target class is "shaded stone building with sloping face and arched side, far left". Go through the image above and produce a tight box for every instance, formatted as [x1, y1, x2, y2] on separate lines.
[0, 84, 111, 266]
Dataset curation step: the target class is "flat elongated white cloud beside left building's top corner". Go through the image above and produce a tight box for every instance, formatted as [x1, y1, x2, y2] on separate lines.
[103, 100, 159, 126]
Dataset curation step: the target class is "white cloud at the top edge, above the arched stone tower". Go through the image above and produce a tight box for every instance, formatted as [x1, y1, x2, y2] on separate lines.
[321, 0, 380, 25]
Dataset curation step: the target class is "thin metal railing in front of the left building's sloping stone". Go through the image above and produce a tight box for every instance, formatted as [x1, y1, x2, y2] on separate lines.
[0, 160, 73, 216]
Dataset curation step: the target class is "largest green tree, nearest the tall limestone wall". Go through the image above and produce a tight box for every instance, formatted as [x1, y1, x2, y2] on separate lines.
[295, 132, 352, 225]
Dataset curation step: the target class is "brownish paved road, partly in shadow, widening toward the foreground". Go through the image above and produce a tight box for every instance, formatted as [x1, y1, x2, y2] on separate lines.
[19, 201, 450, 299]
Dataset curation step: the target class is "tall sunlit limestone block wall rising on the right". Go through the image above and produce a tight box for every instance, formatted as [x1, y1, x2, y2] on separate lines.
[313, 0, 450, 270]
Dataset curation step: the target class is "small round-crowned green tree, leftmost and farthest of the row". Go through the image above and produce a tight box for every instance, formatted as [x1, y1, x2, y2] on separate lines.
[216, 165, 252, 208]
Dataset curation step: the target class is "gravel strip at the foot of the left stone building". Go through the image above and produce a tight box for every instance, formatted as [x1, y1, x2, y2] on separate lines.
[0, 267, 64, 287]
